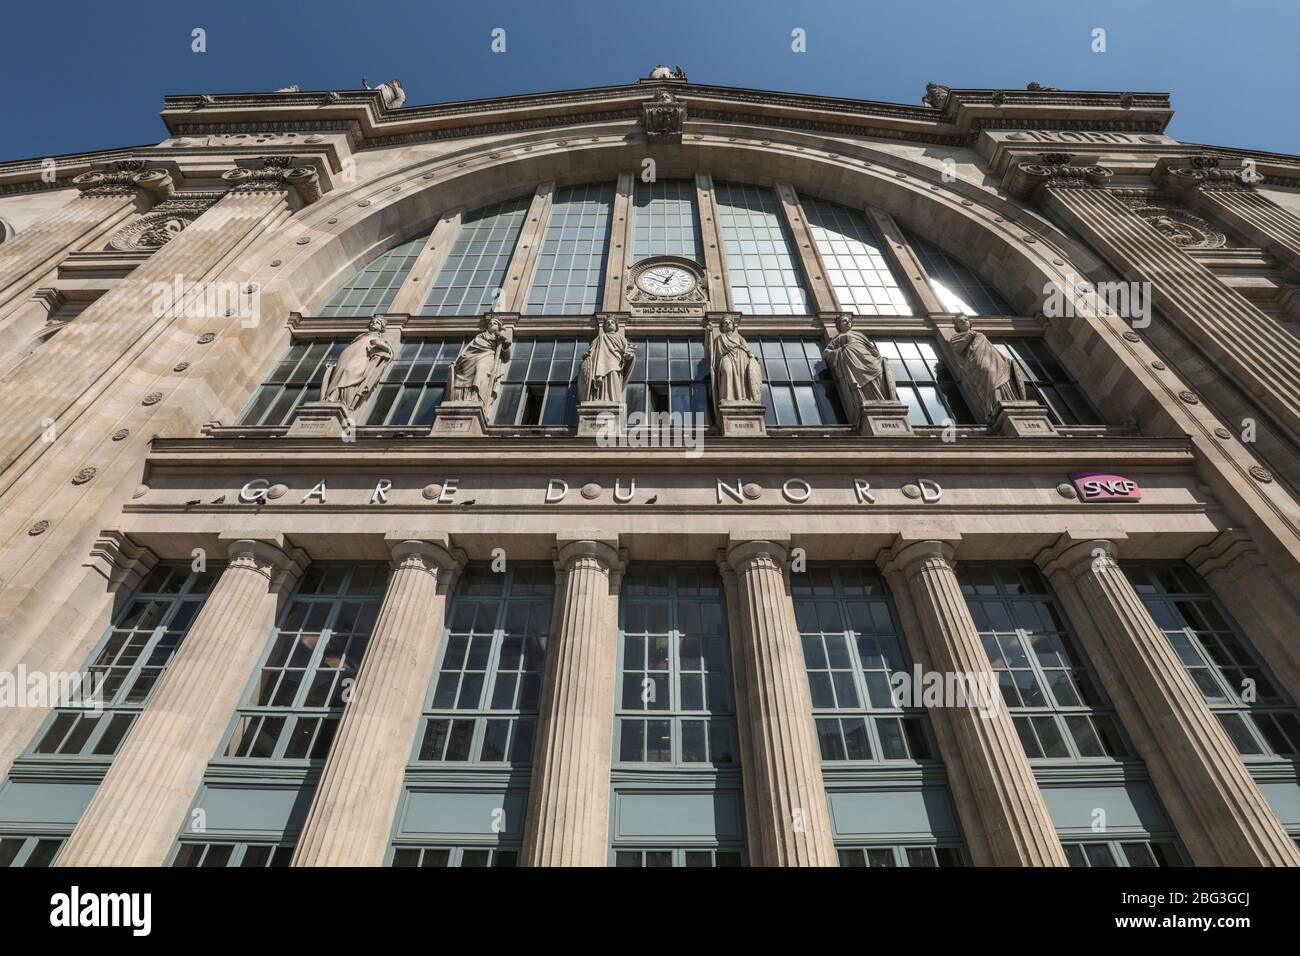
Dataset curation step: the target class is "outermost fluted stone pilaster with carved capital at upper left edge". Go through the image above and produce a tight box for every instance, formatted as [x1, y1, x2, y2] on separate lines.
[0, 167, 147, 316]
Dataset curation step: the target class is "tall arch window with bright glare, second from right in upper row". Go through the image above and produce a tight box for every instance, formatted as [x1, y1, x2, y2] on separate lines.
[802, 199, 917, 315]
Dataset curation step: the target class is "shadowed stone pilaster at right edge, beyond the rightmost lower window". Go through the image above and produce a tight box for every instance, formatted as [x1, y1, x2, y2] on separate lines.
[1187, 528, 1300, 701]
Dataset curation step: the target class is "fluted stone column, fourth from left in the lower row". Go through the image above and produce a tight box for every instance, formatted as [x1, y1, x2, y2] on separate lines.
[727, 541, 837, 866]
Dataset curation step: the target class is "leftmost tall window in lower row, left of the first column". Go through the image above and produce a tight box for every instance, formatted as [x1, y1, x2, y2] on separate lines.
[29, 562, 221, 758]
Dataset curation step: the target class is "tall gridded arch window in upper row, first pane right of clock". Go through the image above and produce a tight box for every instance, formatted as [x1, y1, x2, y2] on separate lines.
[714, 182, 810, 315]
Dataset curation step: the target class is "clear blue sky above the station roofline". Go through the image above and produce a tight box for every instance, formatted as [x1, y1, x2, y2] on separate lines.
[0, 0, 1300, 160]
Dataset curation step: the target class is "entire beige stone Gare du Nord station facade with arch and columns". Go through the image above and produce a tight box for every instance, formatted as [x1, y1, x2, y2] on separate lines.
[0, 68, 1300, 866]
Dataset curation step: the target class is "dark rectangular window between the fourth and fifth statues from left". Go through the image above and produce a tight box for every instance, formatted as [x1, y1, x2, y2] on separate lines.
[749, 338, 848, 425]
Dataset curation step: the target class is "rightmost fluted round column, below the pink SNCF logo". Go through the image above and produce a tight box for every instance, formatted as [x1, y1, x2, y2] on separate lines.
[1043, 537, 1300, 866]
